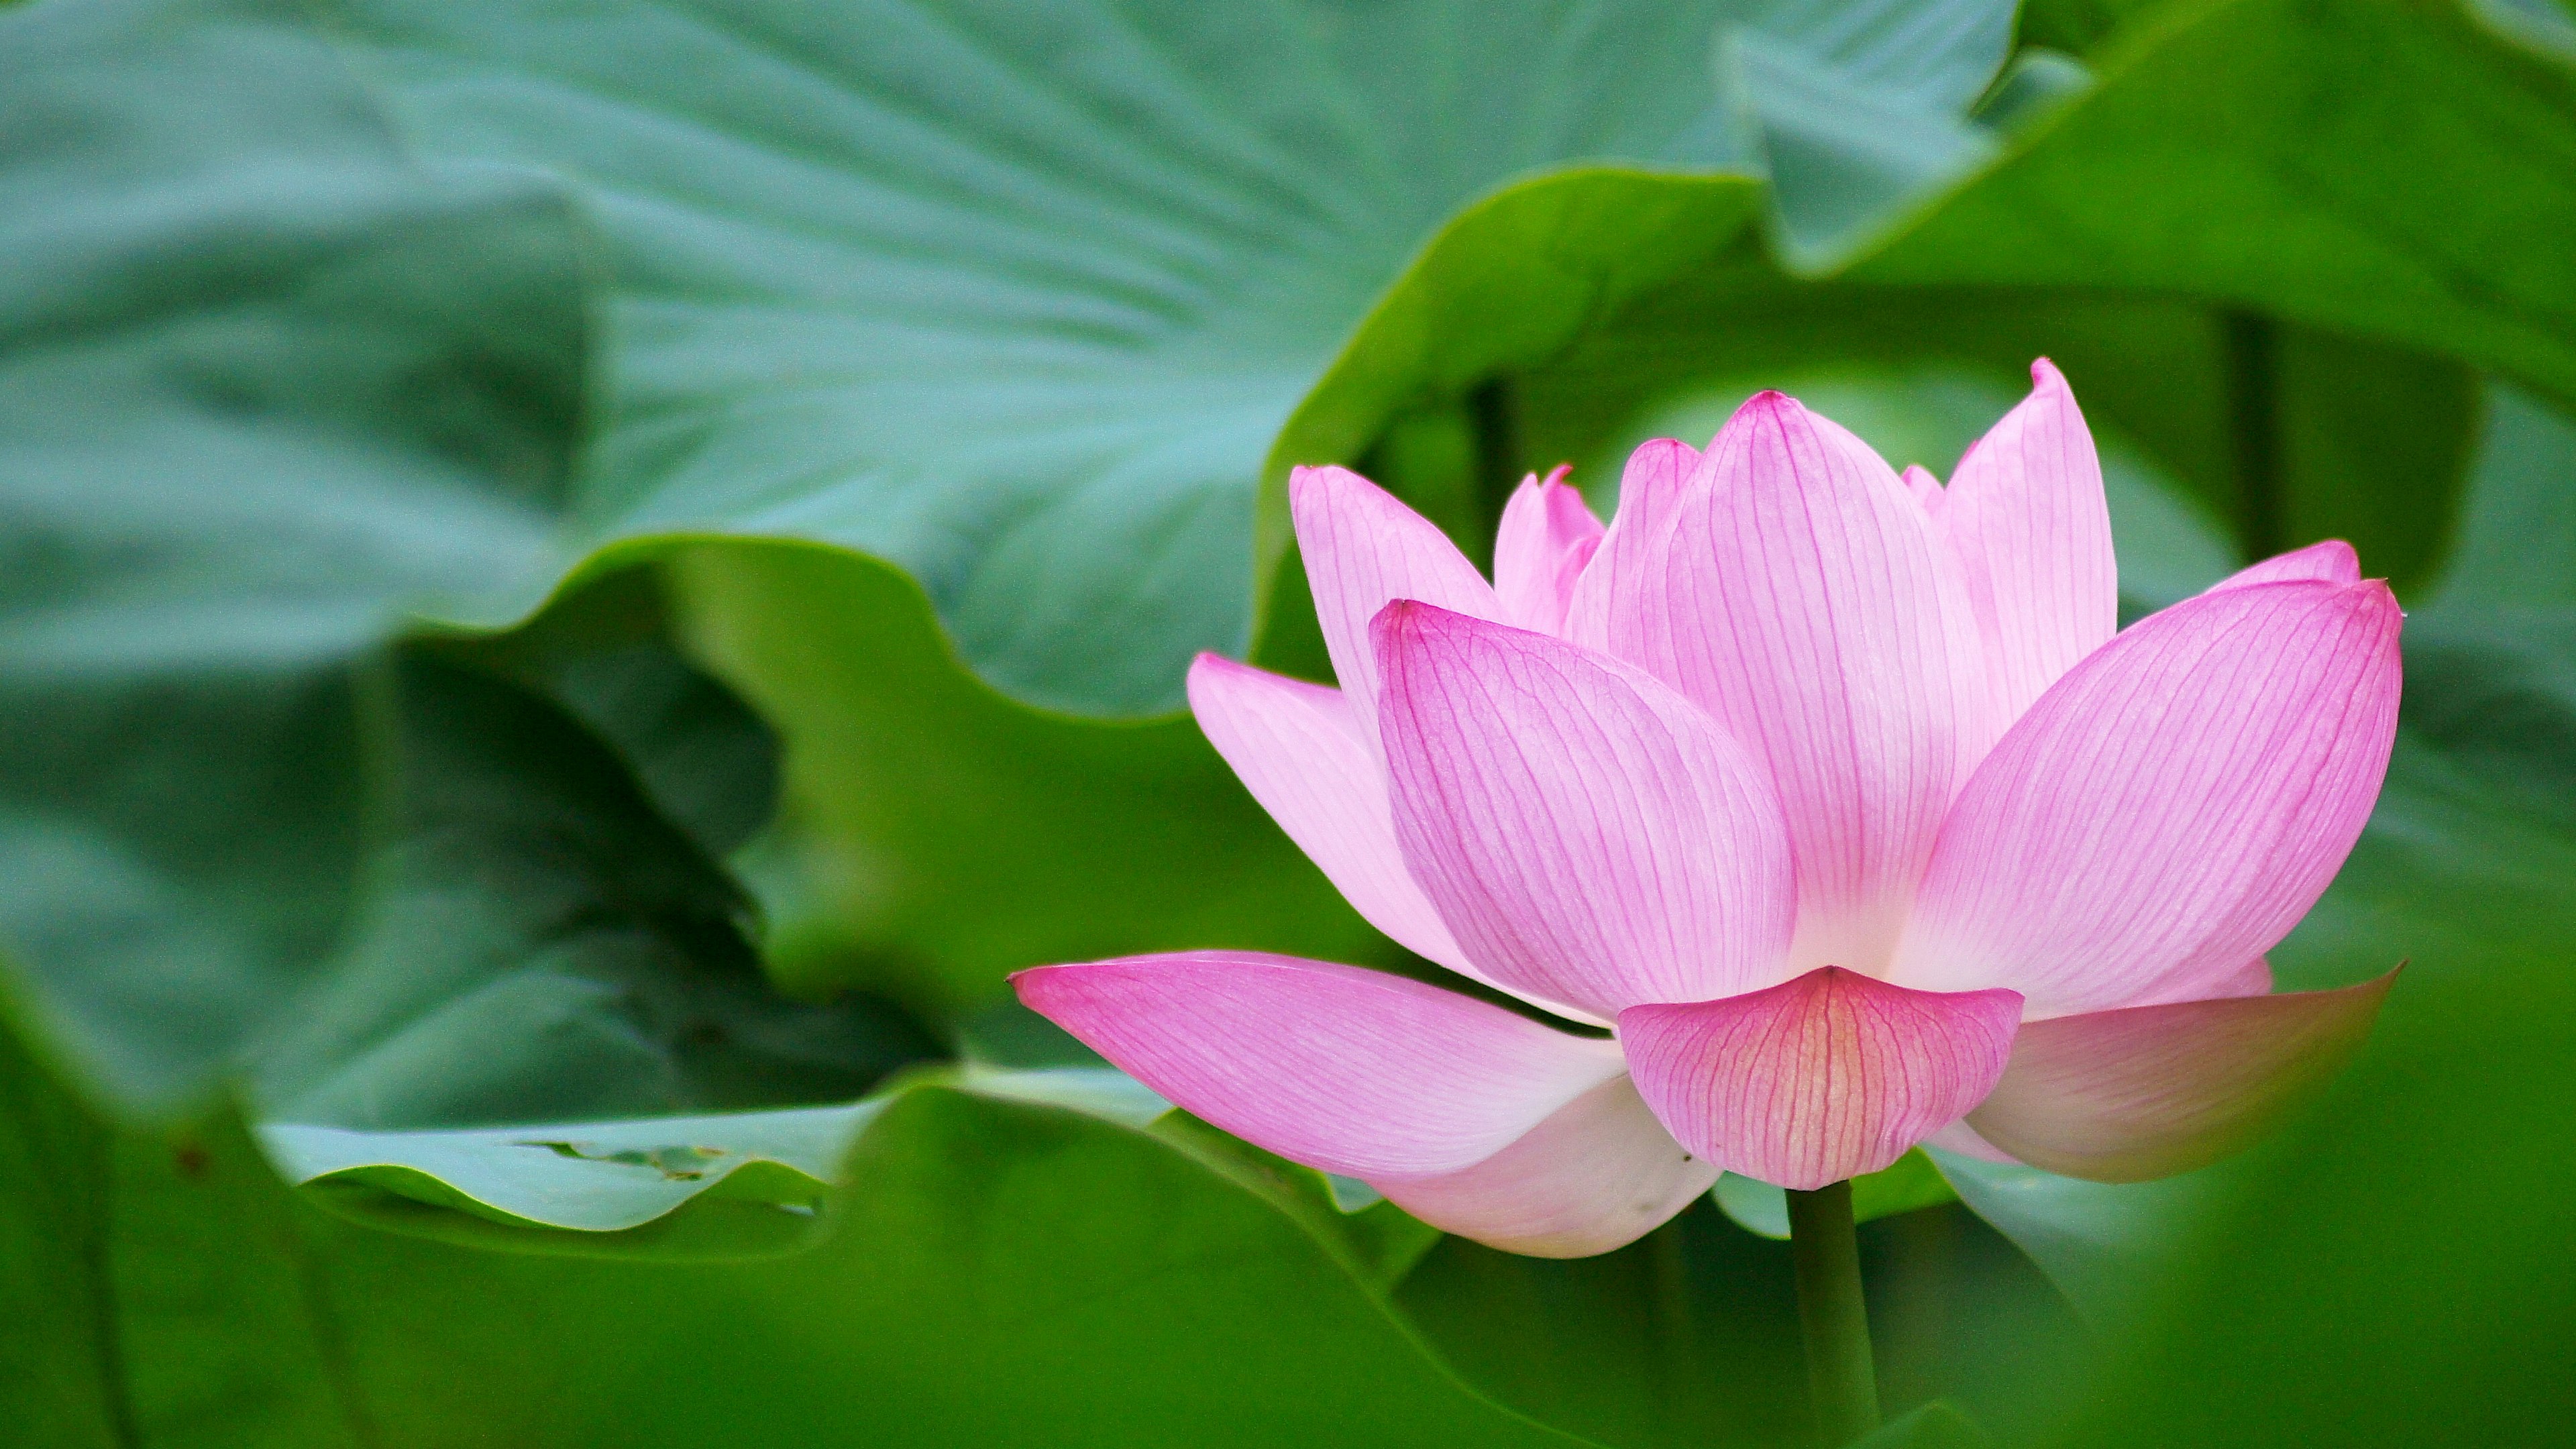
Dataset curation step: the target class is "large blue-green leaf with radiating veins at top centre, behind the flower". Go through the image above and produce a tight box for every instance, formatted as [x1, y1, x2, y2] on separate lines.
[322, 0, 1772, 712]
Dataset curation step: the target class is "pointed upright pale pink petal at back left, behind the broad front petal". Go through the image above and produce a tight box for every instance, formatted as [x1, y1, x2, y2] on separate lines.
[1288, 467, 1502, 753]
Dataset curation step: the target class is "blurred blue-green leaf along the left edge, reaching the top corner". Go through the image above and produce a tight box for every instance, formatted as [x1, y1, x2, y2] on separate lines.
[0, 0, 585, 1112]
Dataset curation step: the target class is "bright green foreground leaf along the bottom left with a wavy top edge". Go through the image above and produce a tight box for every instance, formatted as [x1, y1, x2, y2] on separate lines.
[0, 1016, 1607, 1449]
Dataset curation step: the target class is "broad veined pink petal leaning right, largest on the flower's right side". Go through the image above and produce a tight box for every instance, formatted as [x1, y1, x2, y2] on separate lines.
[1893, 580, 2401, 1018]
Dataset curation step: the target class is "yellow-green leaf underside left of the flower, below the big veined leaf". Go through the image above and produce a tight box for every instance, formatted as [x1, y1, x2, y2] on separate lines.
[675, 544, 1391, 1016]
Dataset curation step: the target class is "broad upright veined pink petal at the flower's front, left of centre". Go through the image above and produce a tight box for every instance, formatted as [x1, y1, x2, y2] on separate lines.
[1376, 601, 1793, 1016]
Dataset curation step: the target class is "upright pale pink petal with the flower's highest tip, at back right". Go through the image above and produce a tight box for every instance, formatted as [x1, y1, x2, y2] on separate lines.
[1940, 358, 2120, 719]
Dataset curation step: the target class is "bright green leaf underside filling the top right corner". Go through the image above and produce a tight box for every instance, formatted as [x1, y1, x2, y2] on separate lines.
[1849, 0, 2576, 412]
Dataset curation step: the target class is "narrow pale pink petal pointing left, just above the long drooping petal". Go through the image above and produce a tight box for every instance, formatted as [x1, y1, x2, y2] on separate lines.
[1190, 655, 1476, 977]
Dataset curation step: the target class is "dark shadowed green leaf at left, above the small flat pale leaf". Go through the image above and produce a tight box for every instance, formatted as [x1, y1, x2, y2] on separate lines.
[258, 650, 938, 1129]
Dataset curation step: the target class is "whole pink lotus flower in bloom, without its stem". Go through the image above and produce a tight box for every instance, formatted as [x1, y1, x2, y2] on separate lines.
[1015, 361, 2398, 1256]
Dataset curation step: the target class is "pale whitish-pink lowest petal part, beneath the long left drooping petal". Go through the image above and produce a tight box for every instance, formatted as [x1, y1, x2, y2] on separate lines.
[1371, 1075, 1718, 1258]
